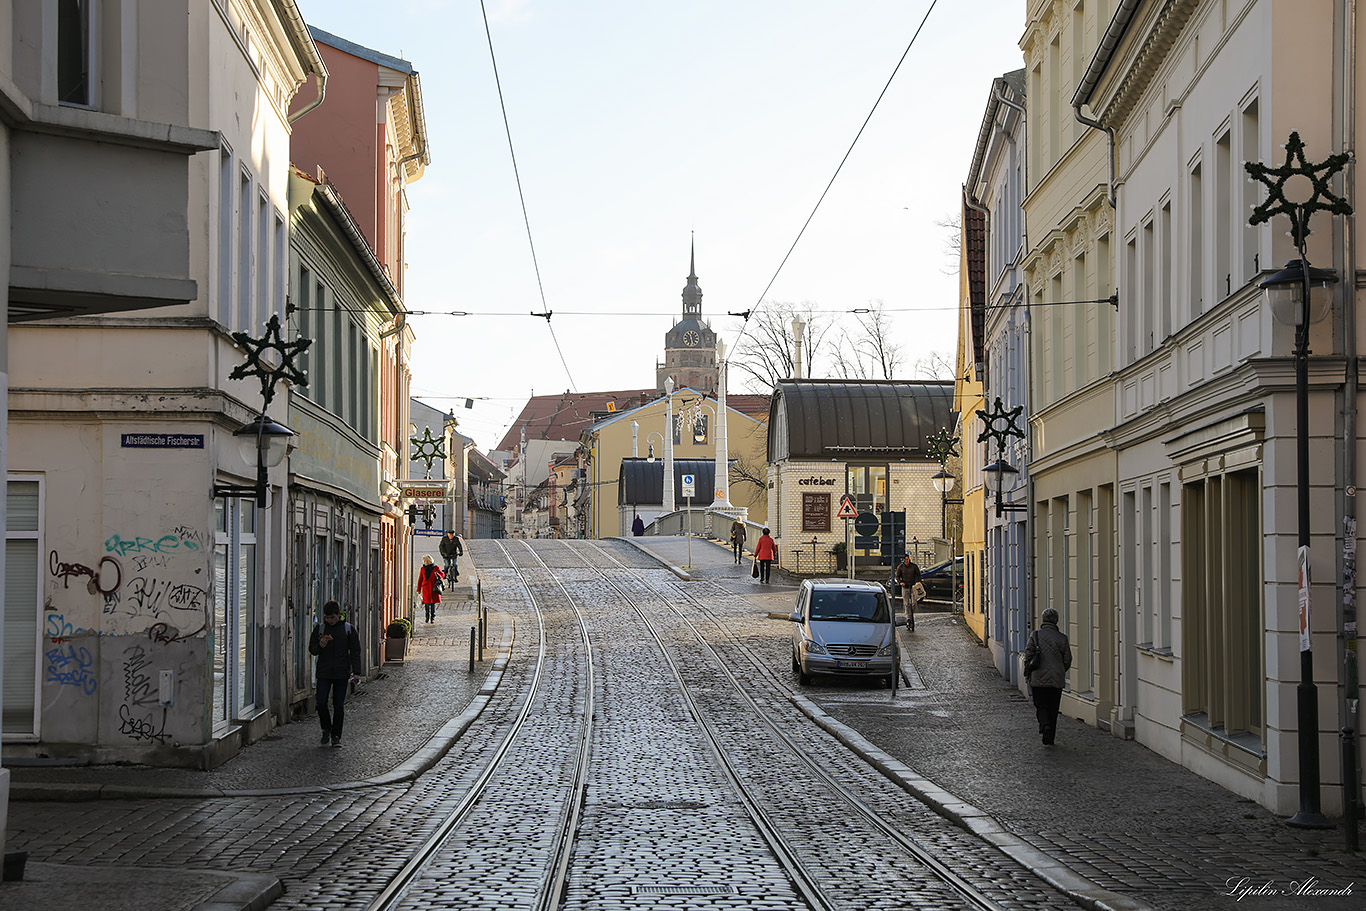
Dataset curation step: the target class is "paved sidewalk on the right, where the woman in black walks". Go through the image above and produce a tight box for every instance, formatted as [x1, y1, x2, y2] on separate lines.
[630, 537, 1366, 911]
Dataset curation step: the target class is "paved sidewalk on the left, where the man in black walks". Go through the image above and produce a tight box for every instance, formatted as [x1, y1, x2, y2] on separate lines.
[0, 584, 512, 911]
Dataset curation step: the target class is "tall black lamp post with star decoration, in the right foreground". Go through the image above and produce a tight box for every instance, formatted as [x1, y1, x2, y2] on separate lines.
[1244, 132, 1356, 835]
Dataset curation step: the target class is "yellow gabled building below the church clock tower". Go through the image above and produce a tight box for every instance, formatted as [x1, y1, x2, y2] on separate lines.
[581, 387, 768, 538]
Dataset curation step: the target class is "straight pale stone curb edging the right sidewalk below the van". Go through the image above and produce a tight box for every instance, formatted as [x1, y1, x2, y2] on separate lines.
[787, 692, 1154, 911]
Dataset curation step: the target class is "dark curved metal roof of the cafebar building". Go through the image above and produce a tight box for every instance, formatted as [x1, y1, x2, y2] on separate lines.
[768, 380, 956, 462]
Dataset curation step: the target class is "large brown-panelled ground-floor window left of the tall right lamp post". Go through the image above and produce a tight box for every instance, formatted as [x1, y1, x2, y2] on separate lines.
[1182, 468, 1265, 739]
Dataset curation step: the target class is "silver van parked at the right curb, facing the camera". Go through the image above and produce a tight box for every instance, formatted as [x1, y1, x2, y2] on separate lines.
[788, 579, 896, 686]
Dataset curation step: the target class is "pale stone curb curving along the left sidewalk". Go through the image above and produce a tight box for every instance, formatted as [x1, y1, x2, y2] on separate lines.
[10, 615, 514, 797]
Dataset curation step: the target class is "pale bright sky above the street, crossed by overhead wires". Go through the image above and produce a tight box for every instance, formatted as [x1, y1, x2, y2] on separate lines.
[296, 0, 1026, 452]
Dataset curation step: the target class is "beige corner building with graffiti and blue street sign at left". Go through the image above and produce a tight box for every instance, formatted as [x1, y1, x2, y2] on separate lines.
[5, 0, 326, 768]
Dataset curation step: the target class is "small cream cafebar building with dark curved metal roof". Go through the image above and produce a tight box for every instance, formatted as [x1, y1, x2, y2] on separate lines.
[768, 380, 956, 574]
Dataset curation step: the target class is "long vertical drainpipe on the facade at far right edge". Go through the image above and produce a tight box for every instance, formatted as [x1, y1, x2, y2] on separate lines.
[1337, 0, 1361, 851]
